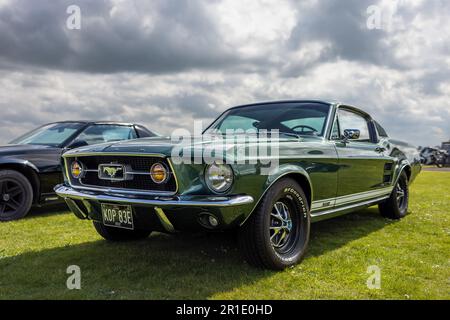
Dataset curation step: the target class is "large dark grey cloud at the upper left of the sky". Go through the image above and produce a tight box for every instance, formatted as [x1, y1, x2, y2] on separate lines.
[0, 0, 236, 73]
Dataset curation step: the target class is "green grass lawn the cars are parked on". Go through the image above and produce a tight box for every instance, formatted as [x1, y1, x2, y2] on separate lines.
[0, 172, 450, 299]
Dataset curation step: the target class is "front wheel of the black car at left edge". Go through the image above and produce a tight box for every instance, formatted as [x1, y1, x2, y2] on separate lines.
[0, 170, 33, 221]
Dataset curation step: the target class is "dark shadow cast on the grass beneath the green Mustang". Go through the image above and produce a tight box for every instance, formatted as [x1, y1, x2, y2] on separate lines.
[0, 208, 389, 299]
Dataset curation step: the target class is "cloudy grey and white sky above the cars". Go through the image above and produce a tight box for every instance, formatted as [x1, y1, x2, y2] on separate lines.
[0, 0, 450, 145]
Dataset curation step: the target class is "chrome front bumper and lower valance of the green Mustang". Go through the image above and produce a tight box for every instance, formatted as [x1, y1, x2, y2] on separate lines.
[55, 185, 254, 232]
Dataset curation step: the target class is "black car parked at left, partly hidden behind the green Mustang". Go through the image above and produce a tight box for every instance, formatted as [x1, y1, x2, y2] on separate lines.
[0, 121, 157, 221]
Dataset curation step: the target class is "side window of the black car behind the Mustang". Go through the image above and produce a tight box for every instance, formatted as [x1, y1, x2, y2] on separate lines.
[77, 125, 137, 145]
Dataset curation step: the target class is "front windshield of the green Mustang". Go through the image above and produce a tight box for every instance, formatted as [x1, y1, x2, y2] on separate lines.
[205, 102, 330, 136]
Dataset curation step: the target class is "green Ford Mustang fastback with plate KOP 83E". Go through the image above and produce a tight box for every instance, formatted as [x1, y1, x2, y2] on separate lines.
[56, 101, 421, 269]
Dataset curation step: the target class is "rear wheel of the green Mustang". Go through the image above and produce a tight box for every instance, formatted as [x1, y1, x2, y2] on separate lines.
[378, 172, 409, 219]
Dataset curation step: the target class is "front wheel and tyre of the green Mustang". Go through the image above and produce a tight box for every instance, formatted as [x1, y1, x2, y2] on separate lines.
[238, 178, 310, 270]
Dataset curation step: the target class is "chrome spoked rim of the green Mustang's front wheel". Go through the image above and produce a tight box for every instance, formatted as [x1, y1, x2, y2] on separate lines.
[270, 201, 293, 250]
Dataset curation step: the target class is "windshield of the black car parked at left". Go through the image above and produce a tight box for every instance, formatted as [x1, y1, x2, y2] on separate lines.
[10, 122, 83, 147]
